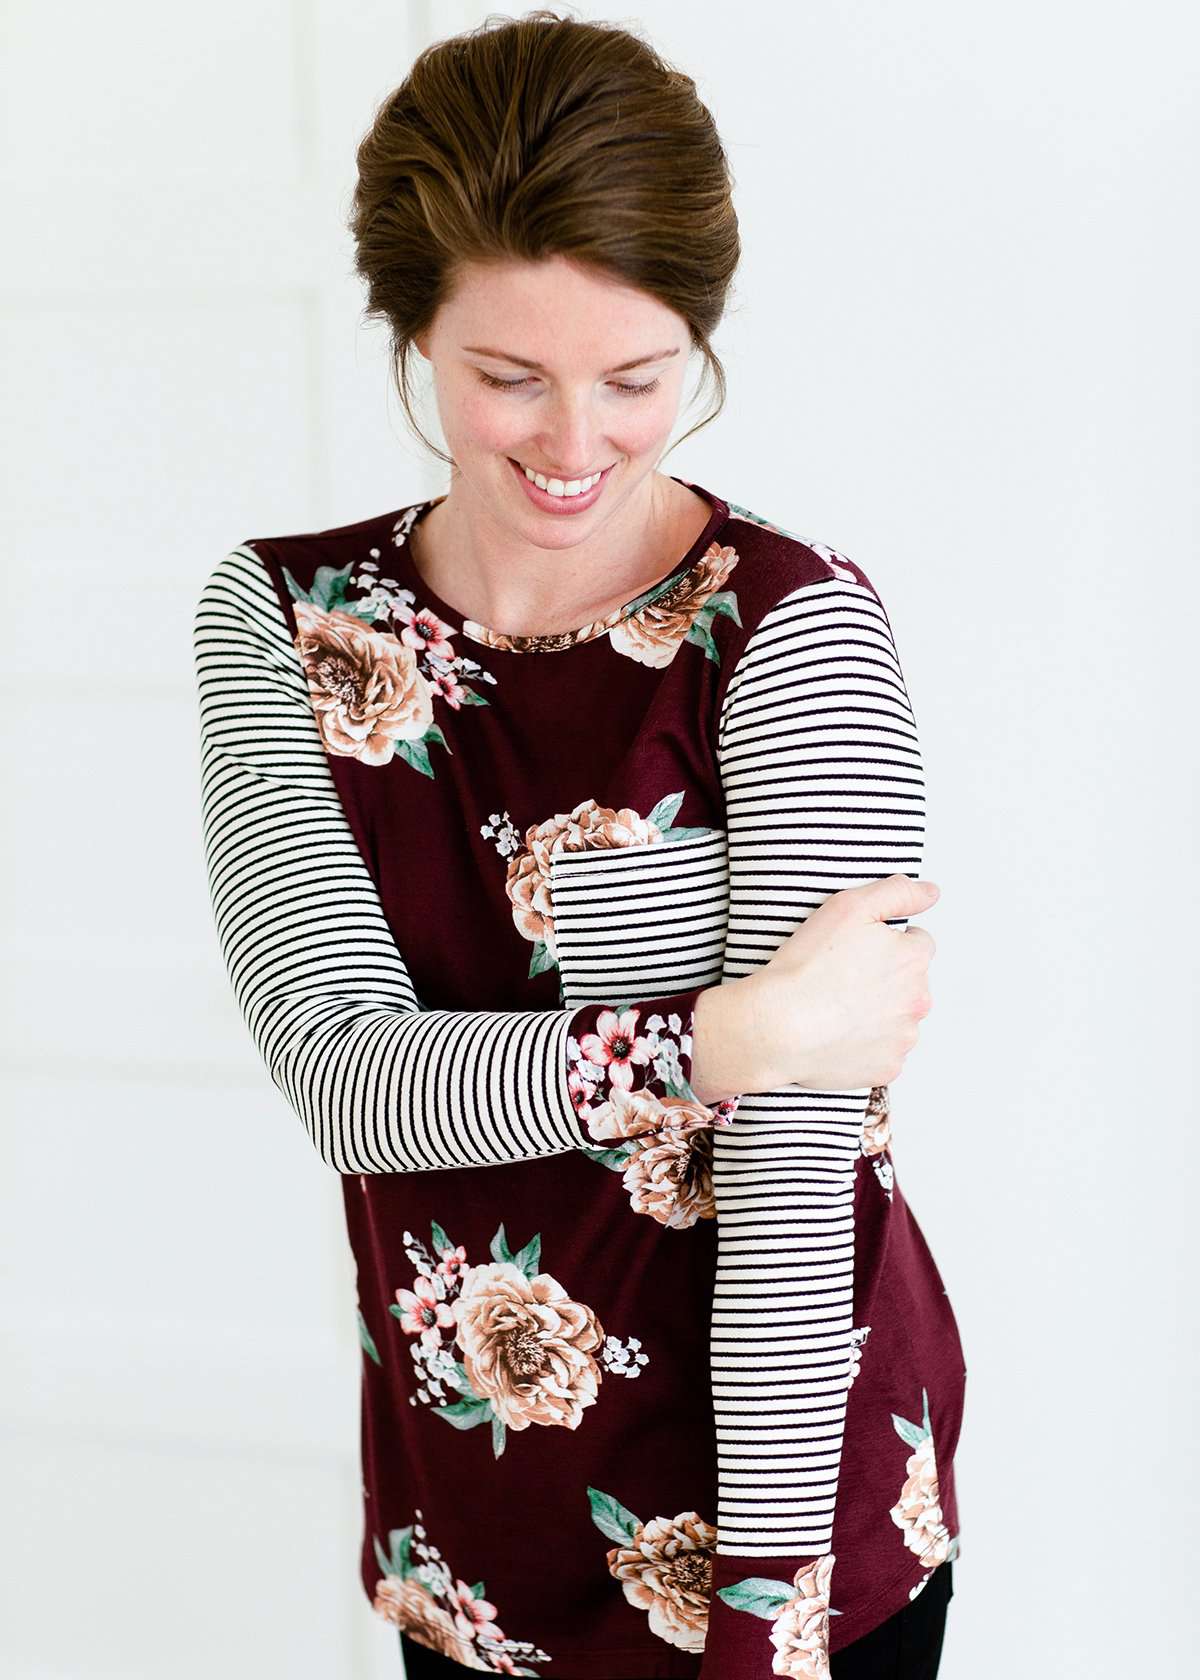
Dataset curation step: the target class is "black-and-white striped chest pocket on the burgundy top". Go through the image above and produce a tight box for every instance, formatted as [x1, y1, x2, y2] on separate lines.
[550, 828, 729, 1008]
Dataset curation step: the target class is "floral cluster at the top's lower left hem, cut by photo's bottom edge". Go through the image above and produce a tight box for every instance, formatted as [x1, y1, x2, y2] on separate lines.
[373, 1510, 551, 1675]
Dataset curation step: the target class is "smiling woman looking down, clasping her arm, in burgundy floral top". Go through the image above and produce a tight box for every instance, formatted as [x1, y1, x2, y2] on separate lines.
[195, 12, 965, 1680]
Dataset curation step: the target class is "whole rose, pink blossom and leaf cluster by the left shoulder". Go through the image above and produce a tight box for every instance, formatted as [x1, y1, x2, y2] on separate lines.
[282, 549, 496, 776]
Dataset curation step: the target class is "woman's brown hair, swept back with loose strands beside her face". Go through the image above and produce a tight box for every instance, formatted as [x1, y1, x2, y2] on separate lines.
[348, 8, 741, 465]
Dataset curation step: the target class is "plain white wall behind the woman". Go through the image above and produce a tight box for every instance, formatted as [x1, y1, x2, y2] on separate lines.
[0, 0, 1200, 1680]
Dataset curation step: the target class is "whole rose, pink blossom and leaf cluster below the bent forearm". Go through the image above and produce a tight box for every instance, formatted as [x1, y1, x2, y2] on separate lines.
[383, 1221, 649, 1458]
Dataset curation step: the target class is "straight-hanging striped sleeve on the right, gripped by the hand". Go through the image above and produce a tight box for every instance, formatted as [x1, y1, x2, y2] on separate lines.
[703, 566, 924, 1680]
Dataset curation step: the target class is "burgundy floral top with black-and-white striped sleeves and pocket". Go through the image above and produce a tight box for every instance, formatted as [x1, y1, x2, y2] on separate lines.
[195, 480, 965, 1680]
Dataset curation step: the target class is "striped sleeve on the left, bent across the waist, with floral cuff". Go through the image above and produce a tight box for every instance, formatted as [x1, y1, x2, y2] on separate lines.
[193, 544, 719, 1173]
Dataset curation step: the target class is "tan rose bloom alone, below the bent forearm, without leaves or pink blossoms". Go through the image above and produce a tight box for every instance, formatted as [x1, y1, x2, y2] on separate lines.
[455, 1260, 603, 1430]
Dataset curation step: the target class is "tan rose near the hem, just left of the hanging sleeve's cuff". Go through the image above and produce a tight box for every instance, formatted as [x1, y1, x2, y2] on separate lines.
[608, 1510, 716, 1651]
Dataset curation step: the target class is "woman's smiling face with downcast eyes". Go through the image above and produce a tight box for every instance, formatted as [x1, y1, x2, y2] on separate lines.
[417, 257, 691, 546]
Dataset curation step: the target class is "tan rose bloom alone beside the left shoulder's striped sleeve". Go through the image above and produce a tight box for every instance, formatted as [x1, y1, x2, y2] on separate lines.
[296, 601, 434, 764]
